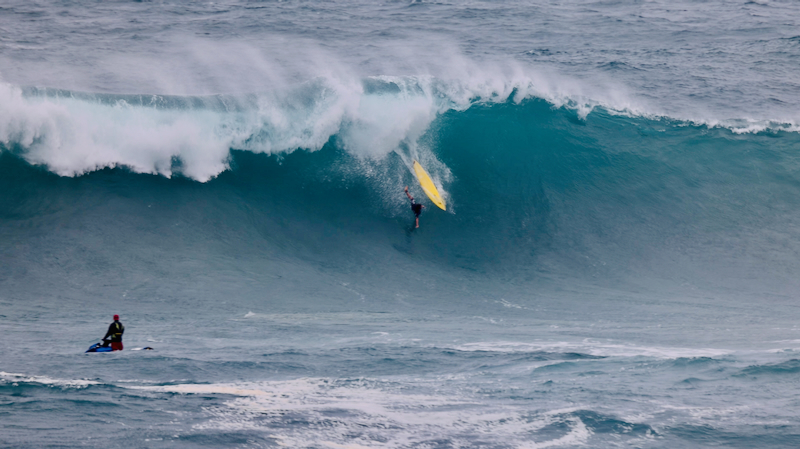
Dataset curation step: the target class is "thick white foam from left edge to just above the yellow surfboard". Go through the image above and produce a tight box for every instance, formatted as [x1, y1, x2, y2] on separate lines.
[0, 75, 440, 182]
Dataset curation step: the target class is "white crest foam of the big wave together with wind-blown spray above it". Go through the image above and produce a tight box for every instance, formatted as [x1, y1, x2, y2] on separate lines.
[0, 43, 800, 186]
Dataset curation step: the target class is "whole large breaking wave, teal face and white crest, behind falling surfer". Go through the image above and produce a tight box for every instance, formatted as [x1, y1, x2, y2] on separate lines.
[2, 89, 800, 294]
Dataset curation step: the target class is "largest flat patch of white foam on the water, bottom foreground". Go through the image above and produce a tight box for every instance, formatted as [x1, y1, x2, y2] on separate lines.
[130, 378, 591, 448]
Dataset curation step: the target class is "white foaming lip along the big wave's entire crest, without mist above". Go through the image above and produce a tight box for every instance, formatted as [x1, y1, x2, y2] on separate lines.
[0, 62, 800, 186]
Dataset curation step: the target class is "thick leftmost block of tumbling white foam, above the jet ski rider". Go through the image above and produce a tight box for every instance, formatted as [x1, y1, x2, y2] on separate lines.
[0, 84, 229, 181]
